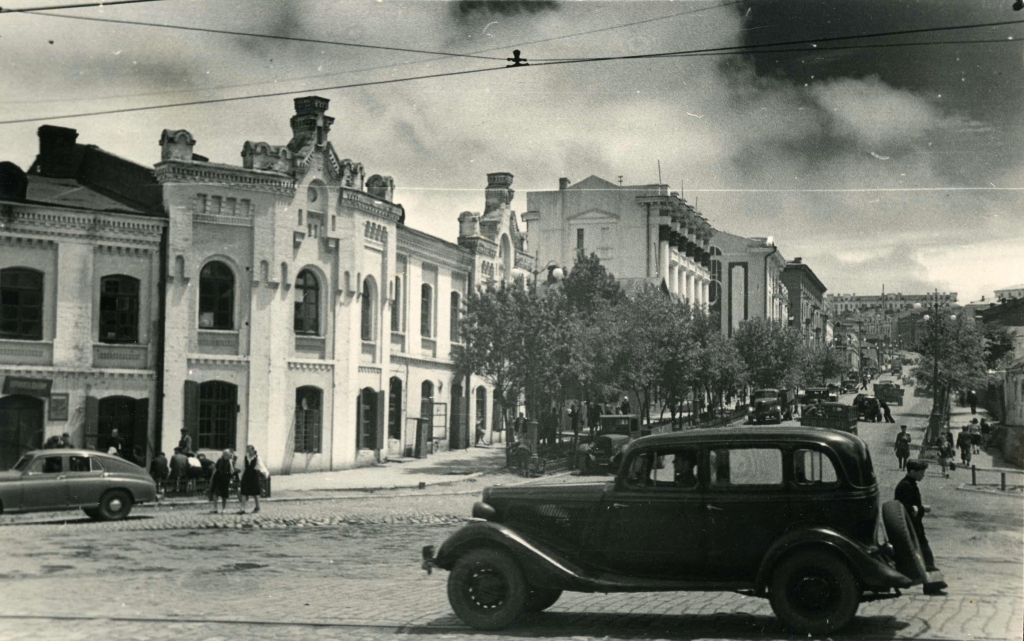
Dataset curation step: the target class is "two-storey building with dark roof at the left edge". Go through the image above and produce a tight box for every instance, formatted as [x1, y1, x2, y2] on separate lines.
[0, 126, 167, 469]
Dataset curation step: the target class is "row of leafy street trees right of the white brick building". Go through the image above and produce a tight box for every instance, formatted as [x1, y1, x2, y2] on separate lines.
[455, 254, 844, 432]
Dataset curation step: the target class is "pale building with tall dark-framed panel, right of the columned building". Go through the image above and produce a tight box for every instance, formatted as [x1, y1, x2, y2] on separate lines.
[711, 229, 790, 337]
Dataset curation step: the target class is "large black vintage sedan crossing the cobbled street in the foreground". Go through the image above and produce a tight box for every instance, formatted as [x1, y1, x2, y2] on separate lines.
[424, 427, 927, 635]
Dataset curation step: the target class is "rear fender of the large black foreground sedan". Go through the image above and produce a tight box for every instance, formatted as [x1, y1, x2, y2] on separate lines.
[757, 527, 914, 591]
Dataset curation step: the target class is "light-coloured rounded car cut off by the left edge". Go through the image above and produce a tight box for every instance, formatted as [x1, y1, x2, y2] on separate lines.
[0, 450, 157, 521]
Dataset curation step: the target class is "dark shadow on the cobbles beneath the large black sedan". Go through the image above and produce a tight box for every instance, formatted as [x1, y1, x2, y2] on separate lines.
[403, 612, 909, 640]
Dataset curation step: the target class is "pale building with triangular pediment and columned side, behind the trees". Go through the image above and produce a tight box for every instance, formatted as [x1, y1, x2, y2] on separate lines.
[523, 176, 714, 308]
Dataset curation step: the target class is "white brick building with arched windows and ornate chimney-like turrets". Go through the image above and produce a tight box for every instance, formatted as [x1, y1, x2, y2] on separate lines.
[156, 96, 532, 473]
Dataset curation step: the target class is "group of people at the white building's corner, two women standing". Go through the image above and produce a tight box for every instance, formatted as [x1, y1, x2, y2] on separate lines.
[150, 430, 270, 514]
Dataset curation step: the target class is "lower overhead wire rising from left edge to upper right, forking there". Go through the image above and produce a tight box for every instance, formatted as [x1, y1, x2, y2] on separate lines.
[0, 16, 1024, 125]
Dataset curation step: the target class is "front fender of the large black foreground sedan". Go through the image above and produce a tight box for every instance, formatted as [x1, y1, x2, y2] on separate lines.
[434, 521, 593, 592]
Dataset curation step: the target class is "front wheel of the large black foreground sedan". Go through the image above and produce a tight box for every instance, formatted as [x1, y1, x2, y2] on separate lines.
[447, 549, 529, 630]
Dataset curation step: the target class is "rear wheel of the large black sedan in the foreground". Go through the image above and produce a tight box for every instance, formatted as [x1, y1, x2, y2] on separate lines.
[768, 550, 860, 635]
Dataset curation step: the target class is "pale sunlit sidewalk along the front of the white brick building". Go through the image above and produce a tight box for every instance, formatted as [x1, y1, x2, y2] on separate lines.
[160, 444, 517, 505]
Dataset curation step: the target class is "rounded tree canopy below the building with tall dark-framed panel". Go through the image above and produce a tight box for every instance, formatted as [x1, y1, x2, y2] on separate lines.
[733, 318, 803, 389]
